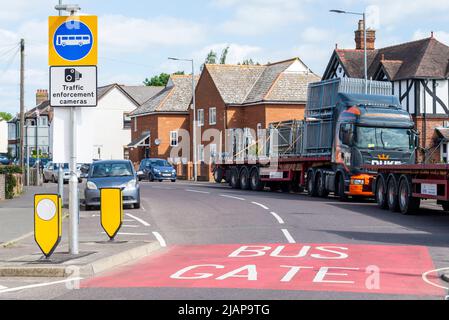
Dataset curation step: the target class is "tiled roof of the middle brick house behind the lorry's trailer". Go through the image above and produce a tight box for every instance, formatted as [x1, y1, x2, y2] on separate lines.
[206, 58, 320, 105]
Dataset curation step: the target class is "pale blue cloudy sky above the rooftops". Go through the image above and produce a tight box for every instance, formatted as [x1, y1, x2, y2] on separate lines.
[0, 0, 449, 113]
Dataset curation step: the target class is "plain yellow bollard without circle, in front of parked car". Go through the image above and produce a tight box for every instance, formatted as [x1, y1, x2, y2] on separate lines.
[100, 188, 123, 240]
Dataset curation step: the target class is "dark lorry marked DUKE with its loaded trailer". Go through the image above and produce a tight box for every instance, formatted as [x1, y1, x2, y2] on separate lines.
[213, 78, 420, 205]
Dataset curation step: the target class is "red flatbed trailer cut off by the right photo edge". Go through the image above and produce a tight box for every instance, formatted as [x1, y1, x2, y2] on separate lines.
[365, 164, 449, 214]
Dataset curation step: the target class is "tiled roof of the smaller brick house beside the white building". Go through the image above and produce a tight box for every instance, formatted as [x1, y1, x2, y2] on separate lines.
[131, 75, 198, 116]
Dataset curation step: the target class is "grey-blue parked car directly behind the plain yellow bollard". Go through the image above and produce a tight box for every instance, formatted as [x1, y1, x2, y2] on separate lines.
[84, 160, 140, 210]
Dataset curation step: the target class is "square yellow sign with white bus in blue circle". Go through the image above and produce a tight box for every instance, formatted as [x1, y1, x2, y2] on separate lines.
[48, 16, 98, 66]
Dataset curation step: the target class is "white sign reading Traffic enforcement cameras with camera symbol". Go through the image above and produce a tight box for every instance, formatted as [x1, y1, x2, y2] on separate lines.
[50, 66, 97, 107]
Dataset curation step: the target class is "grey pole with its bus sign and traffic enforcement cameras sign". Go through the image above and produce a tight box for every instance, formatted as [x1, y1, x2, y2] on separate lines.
[48, 5, 98, 254]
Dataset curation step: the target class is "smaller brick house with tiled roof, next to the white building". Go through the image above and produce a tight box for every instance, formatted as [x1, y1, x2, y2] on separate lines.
[128, 75, 197, 169]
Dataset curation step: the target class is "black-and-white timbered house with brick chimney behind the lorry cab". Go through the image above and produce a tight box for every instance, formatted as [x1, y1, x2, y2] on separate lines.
[323, 21, 449, 163]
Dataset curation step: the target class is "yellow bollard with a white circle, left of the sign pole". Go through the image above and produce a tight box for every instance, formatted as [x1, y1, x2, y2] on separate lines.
[34, 194, 62, 258]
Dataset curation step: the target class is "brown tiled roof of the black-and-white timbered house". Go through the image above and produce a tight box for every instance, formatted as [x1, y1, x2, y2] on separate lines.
[335, 37, 449, 81]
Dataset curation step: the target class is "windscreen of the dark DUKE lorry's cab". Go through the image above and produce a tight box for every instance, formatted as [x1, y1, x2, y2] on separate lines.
[355, 127, 413, 150]
